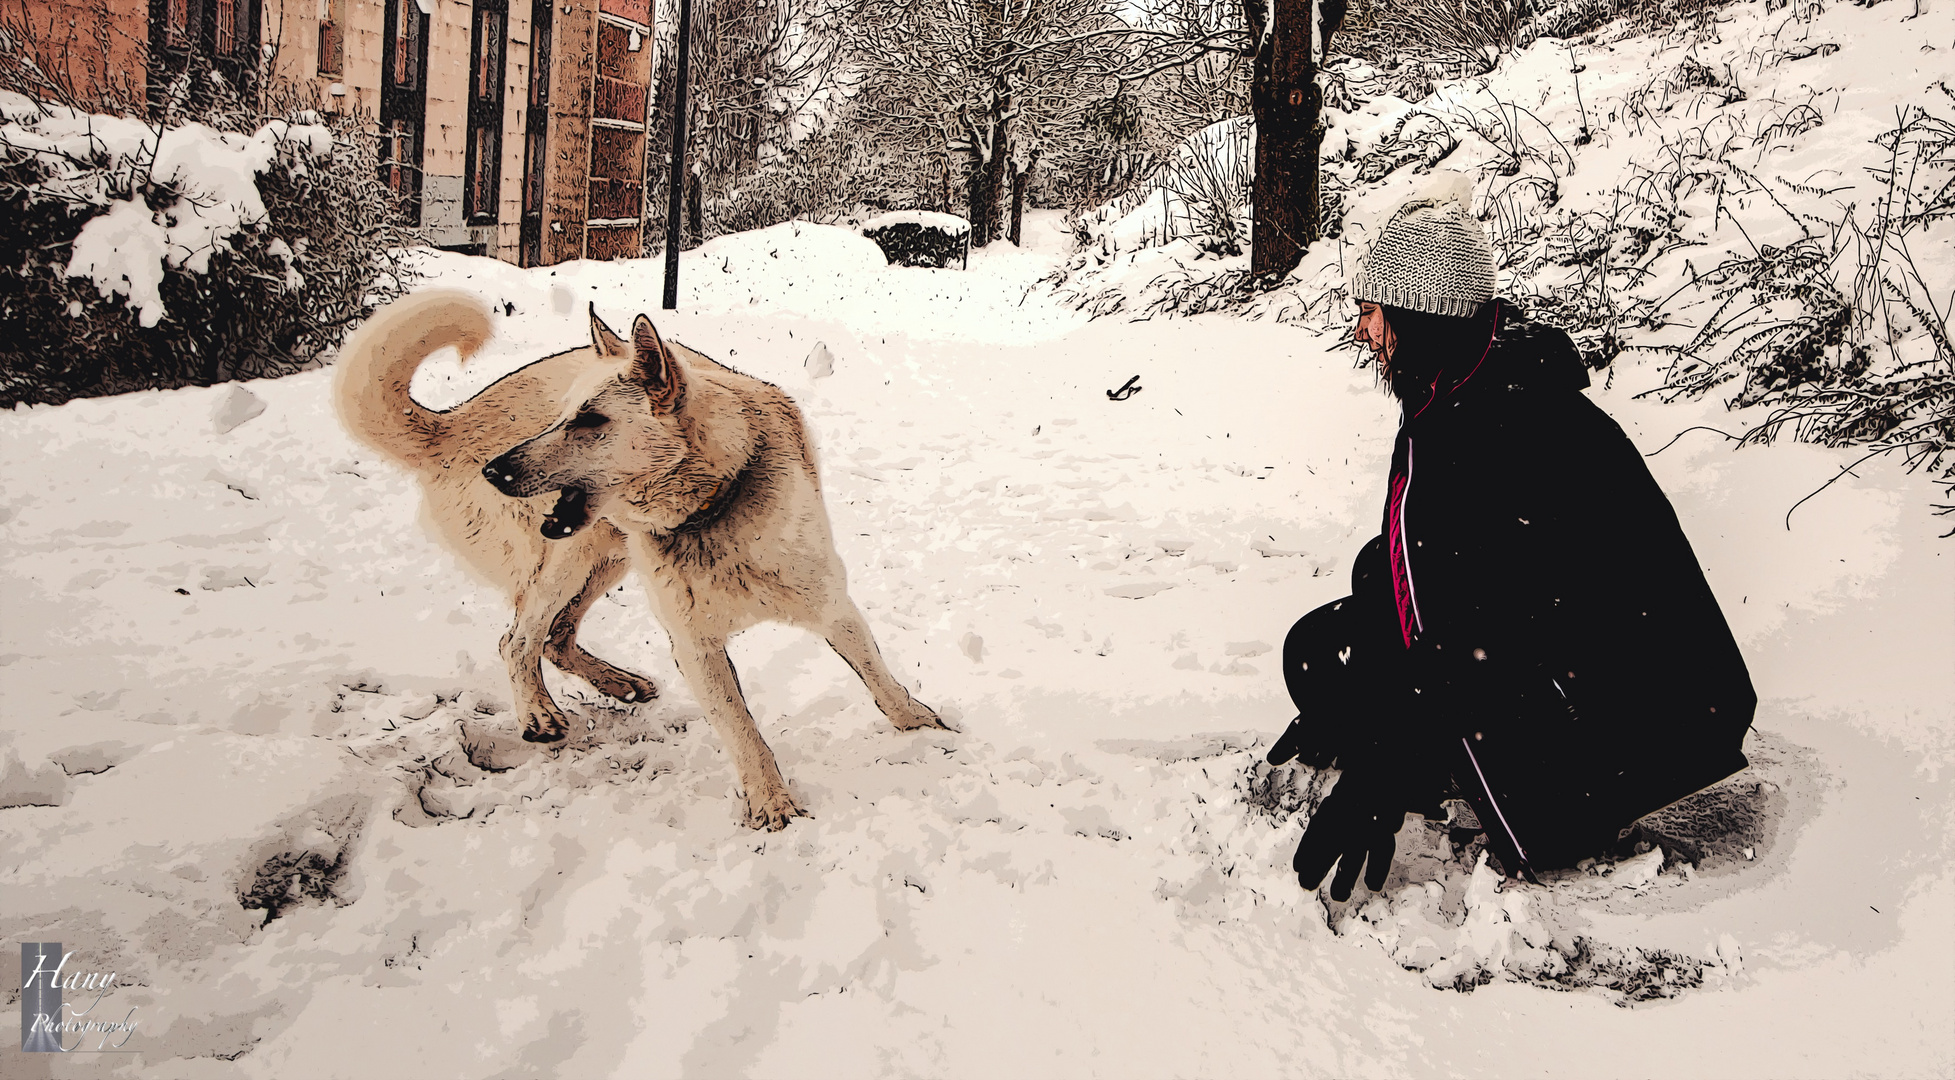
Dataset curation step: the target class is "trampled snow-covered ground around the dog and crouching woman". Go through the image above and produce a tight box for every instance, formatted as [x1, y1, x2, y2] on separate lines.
[0, 4, 1955, 1078]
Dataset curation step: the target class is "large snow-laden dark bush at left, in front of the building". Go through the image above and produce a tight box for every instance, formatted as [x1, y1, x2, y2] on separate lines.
[0, 90, 413, 405]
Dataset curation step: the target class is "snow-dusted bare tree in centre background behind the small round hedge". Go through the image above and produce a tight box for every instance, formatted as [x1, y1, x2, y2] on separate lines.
[839, 0, 1251, 245]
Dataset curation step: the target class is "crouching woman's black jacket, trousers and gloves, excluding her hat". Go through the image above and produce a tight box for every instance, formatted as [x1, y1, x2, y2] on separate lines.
[1271, 301, 1758, 888]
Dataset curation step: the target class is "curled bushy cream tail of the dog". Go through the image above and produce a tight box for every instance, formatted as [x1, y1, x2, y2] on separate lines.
[332, 290, 493, 466]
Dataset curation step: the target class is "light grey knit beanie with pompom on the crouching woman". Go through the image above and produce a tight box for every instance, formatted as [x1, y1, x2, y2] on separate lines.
[1351, 183, 1494, 319]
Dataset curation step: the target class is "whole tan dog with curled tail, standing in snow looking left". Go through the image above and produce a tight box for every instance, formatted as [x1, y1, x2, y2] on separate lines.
[334, 292, 944, 830]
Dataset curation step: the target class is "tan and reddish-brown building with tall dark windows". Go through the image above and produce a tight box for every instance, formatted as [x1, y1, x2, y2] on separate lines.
[0, 0, 655, 266]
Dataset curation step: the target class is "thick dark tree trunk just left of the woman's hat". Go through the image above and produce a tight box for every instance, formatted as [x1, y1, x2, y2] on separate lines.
[1245, 0, 1324, 280]
